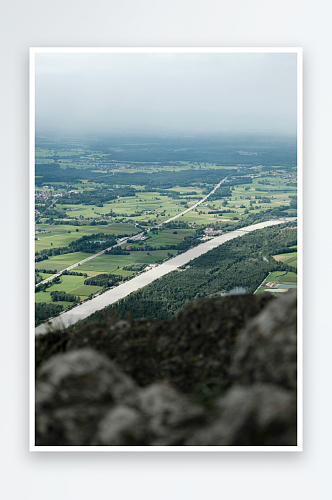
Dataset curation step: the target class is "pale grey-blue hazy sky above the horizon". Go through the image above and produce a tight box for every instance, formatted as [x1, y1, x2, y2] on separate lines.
[36, 53, 297, 134]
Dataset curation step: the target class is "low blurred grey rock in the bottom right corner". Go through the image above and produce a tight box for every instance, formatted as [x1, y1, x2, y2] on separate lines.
[184, 384, 296, 446]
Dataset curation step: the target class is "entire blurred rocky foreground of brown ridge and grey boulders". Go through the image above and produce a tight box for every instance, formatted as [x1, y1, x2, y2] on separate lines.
[36, 291, 297, 446]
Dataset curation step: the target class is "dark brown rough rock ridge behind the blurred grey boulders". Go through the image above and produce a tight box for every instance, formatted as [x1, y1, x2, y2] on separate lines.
[36, 294, 273, 393]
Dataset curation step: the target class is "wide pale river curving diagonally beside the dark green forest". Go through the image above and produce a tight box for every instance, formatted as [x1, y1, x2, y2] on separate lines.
[35, 218, 294, 335]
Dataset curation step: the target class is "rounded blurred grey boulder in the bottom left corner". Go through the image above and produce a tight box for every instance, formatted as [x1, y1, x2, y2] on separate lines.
[36, 349, 137, 446]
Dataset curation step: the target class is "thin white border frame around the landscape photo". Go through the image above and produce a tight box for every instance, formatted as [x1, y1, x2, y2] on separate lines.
[29, 47, 303, 453]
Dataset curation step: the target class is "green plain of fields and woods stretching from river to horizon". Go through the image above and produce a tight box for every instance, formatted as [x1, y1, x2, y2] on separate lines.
[35, 138, 297, 326]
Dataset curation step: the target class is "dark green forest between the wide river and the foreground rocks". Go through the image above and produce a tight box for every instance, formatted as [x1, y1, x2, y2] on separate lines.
[84, 222, 296, 320]
